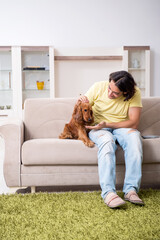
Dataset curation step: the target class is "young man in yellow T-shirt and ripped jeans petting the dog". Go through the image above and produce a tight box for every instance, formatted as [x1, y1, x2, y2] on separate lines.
[80, 71, 144, 208]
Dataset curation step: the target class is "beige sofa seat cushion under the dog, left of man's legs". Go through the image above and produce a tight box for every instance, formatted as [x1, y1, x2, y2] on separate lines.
[22, 138, 97, 165]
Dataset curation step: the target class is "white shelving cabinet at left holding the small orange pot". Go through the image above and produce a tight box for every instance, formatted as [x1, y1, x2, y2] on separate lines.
[0, 46, 55, 119]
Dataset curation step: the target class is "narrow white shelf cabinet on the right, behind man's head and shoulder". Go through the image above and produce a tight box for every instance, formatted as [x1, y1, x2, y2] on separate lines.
[123, 46, 150, 97]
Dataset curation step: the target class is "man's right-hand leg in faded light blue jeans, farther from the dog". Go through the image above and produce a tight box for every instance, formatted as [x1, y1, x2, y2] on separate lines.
[113, 128, 143, 203]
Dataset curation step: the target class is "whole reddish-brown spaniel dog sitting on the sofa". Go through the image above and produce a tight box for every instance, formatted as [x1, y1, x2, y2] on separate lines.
[59, 101, 94, 147]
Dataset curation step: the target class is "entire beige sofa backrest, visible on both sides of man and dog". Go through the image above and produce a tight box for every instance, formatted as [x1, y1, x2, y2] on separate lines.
[24, 97, 160, 140]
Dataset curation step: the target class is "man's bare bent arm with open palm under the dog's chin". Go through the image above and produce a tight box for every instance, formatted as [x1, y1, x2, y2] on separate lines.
[86, 107, 142, 130]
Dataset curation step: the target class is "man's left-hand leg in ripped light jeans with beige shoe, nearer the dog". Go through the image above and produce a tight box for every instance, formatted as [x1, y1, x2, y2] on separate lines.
[89, 129, 125, 208]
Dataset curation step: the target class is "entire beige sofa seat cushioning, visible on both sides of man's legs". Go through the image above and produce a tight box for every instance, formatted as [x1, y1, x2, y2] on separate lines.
[22, 138, 160, 166]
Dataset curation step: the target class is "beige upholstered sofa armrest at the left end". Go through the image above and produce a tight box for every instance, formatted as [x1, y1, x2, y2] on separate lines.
[0, 119, 24, 187]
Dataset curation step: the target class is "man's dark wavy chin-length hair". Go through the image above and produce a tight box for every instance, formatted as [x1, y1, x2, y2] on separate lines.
[109, 71, 137, 101]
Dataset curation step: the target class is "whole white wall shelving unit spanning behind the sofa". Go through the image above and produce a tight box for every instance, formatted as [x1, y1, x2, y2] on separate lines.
[0, 46, 150, 119]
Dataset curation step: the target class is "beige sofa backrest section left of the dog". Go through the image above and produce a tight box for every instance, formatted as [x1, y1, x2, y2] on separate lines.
[24, 98, 76, 141]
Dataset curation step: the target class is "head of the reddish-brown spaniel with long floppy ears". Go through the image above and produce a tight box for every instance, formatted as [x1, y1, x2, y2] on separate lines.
[72, 101, 94, 125]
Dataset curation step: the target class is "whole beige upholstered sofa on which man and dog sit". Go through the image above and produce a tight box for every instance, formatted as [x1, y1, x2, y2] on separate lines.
[0, 97, 160, 191]
